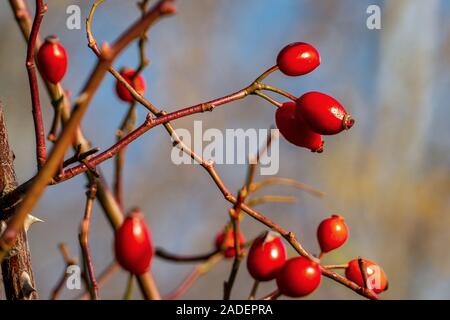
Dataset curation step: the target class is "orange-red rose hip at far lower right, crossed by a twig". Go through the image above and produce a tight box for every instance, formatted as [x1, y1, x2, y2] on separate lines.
[345, 259, 388, 293]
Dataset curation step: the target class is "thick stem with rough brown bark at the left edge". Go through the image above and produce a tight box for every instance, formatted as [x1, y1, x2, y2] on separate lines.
[0, 104, 38, 300]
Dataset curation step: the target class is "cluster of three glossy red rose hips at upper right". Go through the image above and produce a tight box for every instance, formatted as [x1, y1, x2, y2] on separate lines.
[275, 42, 354, 152]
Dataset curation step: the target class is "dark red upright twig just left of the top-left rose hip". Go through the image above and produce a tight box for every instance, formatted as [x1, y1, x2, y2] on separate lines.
[26, 0, 47, 169]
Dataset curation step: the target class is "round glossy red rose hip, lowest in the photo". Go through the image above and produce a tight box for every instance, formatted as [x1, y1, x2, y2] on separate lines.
[277, 257, 322, 298]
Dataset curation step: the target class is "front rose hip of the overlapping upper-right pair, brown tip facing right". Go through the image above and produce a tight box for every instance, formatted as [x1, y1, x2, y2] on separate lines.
[296, 92, 355, 135]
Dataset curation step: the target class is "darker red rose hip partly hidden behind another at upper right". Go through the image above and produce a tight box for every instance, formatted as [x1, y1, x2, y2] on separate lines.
[275, 102, 324, 153]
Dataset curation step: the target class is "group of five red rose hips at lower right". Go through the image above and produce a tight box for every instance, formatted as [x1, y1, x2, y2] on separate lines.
[216, 215, 387, 298]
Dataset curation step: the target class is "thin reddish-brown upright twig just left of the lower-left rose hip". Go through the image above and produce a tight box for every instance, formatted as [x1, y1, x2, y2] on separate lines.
[79, 178, 98, 300]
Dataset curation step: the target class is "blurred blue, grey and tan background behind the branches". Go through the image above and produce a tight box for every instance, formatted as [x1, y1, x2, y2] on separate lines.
[0, 0, 450, 299]
